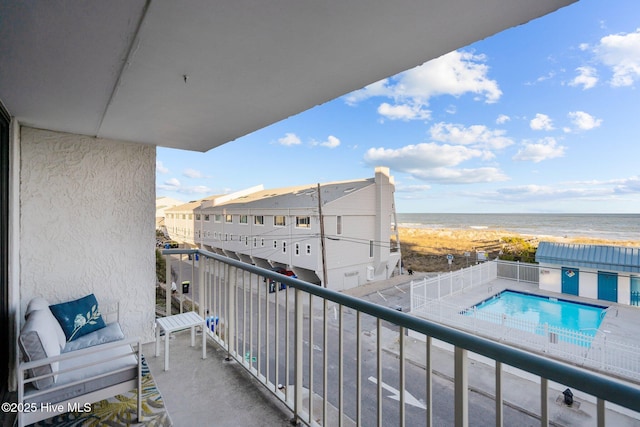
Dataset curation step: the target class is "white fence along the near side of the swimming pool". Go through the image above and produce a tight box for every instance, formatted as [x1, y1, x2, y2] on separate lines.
[412, 297, 640, 381]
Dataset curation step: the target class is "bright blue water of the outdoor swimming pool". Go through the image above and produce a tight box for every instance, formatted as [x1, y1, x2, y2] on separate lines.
[467, 291, 607, 342]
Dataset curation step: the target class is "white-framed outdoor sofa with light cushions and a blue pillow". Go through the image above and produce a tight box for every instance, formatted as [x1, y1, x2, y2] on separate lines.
[16, 294, 142, 427]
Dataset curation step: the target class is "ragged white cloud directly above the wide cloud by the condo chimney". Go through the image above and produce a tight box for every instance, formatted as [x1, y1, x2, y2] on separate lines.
[429, 122, 513, 150]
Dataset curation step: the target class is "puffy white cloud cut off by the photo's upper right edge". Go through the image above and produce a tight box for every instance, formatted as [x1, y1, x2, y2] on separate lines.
[595, 28, 640, 87]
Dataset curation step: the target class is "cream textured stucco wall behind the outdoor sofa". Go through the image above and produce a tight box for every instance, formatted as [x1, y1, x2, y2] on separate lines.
[20, 127, 155, 342]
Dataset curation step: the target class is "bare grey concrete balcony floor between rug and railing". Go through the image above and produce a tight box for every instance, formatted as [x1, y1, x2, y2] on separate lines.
[142, 329, 292, 427]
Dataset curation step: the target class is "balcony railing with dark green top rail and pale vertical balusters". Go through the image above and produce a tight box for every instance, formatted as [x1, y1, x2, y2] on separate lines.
[163, 249, 640, 426]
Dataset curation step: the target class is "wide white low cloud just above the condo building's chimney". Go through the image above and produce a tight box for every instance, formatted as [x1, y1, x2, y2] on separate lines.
[364, 143, 507, 184]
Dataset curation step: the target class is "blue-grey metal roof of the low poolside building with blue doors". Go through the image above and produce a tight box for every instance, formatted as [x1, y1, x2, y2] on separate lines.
[536, 242, 640, 273]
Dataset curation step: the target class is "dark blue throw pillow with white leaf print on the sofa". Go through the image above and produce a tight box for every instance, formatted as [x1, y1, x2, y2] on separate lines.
[49, 294, 106, 342]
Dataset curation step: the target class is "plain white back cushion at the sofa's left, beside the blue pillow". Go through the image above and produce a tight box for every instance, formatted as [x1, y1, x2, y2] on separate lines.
[18, 310, 60, 389]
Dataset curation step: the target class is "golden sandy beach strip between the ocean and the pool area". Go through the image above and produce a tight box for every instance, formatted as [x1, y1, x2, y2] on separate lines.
[398, 227, 640, 272]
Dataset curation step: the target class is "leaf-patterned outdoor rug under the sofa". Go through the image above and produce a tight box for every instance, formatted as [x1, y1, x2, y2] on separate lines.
[33, 356, 173, 427]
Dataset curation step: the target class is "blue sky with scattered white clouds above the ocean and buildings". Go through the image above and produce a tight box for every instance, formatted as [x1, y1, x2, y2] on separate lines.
[156, 0, 640, 213]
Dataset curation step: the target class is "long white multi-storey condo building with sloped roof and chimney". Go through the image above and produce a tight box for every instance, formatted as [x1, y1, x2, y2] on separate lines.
[165, 167, 400, 290]
